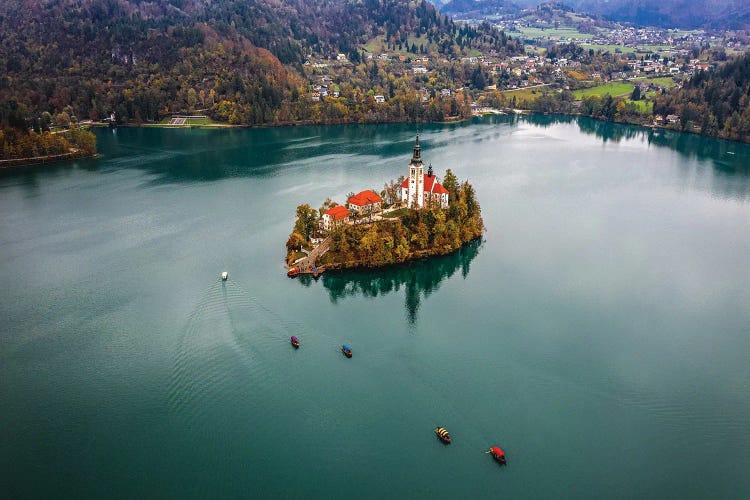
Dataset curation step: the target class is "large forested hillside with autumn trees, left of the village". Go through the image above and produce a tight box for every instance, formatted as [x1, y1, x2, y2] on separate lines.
[0, 0, 519, 125]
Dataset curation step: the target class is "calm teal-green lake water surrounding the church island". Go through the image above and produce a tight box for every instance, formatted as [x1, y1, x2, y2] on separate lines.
[0, 117, 750, 499]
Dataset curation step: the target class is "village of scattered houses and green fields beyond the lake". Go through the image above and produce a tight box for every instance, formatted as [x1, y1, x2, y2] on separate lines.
[304, 9, 750, 131]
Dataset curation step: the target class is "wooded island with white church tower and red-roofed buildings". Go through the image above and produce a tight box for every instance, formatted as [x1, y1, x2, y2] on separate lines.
[286, 135, 484, 276]
